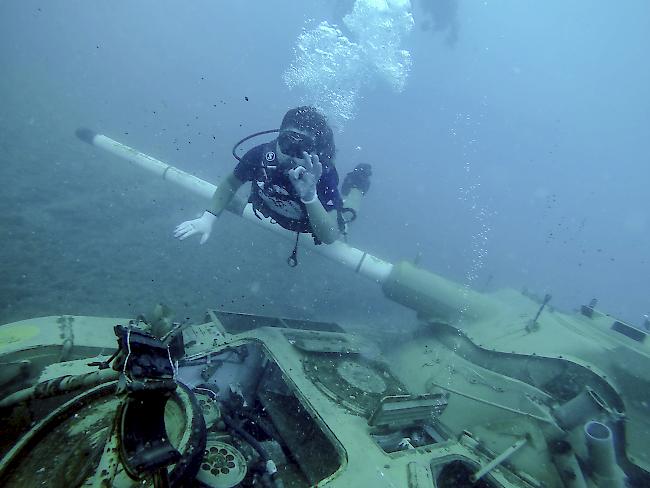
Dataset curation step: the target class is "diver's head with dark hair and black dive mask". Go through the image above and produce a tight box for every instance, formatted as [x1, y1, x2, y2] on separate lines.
[277, 106, 335, 166]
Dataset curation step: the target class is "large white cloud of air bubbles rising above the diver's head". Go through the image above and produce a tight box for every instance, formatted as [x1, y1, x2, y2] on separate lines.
[284, 0, 414, 130]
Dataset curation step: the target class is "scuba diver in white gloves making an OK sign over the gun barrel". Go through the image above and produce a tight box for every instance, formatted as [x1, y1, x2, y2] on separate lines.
[174, 106, 372, 266]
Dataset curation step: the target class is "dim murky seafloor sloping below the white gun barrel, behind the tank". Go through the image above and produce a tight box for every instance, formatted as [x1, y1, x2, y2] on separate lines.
[0, 80, 415, 340]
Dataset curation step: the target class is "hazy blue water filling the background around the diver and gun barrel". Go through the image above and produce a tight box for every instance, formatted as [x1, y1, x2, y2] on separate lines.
[0, 0, 650, 330]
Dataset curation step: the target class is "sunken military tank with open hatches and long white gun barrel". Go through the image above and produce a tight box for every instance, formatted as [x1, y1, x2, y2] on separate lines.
[0, 131, 650, 488]
